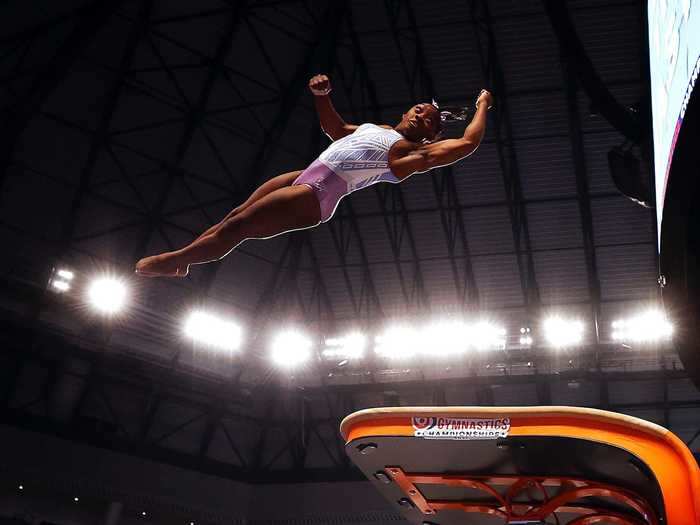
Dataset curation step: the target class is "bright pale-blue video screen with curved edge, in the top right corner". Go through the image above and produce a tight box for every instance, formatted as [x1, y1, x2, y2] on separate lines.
[648, 0, 700, 247]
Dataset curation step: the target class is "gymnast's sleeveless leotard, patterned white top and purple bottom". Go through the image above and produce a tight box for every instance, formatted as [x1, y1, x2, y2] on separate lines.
[292, 124, 404, 222]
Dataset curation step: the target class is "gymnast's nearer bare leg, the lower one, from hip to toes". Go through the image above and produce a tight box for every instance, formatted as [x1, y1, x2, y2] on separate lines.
[136, 185, 321, 276]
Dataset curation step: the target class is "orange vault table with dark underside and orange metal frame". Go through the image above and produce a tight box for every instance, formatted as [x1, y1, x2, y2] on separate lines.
[340, 407, 700, 525]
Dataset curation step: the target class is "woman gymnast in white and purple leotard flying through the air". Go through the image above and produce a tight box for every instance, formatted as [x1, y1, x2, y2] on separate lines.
[136, 75, 493, 277]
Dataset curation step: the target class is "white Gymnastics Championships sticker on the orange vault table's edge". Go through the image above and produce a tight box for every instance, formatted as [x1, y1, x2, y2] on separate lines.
[411, 417, 510, 440]
